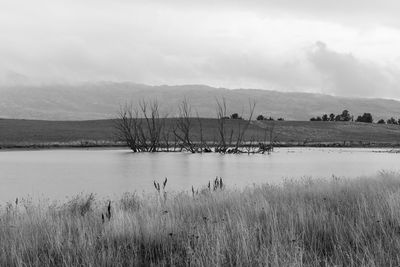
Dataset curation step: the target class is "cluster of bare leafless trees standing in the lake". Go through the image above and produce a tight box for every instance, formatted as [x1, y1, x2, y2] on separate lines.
[115, 99, 274, 153]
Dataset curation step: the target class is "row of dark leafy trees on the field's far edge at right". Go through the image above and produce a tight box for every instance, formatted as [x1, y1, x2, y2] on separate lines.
[310, 110, 400, 125]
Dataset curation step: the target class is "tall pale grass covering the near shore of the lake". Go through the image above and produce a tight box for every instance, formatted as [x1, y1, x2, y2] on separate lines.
[0, 174, 400, 266]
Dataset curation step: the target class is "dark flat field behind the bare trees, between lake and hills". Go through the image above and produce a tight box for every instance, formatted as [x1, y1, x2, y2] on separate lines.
[0, 119, 400, 148]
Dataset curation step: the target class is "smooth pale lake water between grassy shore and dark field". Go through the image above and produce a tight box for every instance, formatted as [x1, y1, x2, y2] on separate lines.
[0, 148, 400, 204]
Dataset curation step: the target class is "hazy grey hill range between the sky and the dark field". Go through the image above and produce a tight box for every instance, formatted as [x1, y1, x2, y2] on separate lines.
[0, 82, 400, 121]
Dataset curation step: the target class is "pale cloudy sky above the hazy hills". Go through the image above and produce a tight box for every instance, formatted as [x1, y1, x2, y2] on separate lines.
[0, 0, 400, 99]
